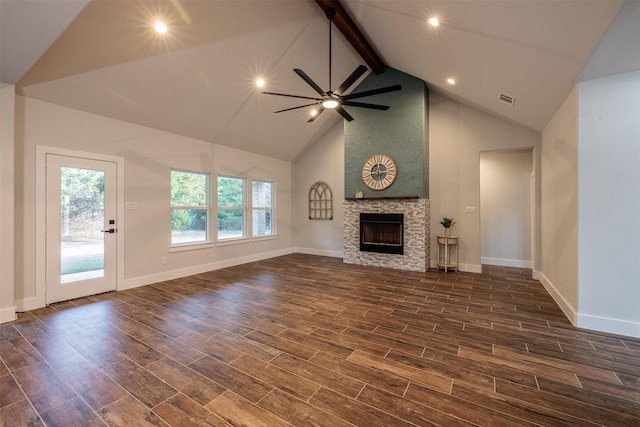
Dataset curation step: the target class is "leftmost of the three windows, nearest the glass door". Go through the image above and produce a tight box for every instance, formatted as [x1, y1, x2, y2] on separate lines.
[171, 170, 211, 245]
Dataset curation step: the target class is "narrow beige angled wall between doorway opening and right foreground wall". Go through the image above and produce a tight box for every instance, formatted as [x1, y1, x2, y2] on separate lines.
[540, 89, 578, 324]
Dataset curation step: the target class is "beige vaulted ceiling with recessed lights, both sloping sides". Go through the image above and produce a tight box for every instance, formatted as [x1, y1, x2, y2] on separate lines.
[0, 0, 623, 160]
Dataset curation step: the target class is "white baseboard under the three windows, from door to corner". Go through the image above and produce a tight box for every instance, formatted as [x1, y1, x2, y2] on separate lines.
[118, 249, 292, 291]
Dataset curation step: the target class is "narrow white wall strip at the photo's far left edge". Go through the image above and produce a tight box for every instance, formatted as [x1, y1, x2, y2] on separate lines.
[0, 84, 16, 323]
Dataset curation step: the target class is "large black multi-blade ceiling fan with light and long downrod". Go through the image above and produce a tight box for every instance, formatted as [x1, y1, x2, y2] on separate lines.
[262, 8, 402, 122]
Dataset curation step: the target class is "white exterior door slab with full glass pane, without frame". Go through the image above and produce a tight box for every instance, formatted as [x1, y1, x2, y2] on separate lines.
[45, 154, 118, 304]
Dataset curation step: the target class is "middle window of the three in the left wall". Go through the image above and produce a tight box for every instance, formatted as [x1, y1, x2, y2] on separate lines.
[218, 176, 246, 240]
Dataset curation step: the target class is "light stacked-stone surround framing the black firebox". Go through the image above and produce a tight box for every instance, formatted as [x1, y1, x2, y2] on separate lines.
[343, 199, 431, 272]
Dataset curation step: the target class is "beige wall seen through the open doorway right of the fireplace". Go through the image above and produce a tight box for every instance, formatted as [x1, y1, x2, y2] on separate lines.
[480, 149, 533, 268]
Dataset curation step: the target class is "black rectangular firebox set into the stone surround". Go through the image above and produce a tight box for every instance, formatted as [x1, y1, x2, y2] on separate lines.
[360, 213, 404, 255]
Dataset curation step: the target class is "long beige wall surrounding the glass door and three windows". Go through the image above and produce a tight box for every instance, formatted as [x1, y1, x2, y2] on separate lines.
[16, 96, 292, 309]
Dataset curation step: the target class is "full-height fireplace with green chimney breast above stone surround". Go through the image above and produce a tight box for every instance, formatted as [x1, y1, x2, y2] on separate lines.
[343, 67, 430, 272]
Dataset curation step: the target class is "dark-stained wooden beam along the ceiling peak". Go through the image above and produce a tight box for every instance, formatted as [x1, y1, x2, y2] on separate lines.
[316, 0, 384, 74]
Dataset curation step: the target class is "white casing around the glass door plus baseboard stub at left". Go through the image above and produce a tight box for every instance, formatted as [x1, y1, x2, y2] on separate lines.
[34, 145, 125, 311]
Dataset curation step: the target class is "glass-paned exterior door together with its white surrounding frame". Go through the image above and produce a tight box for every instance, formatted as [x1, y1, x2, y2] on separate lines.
[36, 146, 124, 306]
